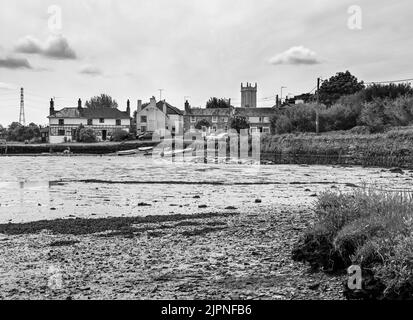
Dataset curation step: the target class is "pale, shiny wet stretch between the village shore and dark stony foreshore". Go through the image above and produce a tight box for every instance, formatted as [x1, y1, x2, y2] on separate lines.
[0, 156, 413, 223]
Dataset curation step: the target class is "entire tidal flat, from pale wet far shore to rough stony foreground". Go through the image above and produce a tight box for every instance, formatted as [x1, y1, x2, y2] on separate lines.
[0, 157, 413, 299]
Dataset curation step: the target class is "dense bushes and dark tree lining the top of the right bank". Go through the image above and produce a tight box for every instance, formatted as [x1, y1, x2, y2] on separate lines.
[271, 73, 413, 134]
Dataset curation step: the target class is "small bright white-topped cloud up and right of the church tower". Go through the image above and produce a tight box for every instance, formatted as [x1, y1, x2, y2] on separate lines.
[270, 46, 321, 65]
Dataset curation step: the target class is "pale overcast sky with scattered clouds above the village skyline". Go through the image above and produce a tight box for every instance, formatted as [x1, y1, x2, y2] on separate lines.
[0, 0, 413, 126]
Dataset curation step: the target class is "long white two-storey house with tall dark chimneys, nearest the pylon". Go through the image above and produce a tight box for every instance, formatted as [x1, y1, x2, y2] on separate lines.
[48, 99, 131, 143]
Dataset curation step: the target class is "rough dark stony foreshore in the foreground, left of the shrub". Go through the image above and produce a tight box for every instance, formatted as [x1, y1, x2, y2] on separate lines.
[0, 205, 344, 299]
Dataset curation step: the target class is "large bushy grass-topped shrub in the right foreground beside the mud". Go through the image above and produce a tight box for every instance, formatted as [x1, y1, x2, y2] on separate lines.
[292, 189, 413, 299]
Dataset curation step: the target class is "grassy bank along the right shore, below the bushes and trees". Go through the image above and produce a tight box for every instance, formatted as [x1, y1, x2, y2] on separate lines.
[261, 128, 413, 169]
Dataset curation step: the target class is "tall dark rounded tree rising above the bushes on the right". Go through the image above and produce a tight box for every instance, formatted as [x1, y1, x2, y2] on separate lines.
[319, 71, 365, 106]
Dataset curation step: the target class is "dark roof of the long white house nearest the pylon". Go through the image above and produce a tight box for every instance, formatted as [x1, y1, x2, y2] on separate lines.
[49, 107, 130, 119]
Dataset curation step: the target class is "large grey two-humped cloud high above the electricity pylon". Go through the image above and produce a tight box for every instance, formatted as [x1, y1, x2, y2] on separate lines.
[15, 35, 77, 60]
